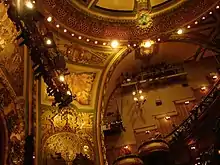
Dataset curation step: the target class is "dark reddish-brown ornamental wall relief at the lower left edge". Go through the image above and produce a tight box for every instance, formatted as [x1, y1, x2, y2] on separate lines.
[0, 82, 25, 165]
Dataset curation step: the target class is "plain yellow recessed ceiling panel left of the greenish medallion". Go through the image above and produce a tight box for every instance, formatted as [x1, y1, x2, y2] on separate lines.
[96, 0, 134, 11]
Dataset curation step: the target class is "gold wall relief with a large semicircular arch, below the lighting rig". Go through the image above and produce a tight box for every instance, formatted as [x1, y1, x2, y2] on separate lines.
[41, 105, 94, 161]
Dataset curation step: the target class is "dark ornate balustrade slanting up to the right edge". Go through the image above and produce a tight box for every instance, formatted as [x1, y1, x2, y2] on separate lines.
[164, 80, 220, 143]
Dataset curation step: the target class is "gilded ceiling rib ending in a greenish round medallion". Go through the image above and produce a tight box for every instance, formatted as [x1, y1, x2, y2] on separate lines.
[137, 0, 153, 29]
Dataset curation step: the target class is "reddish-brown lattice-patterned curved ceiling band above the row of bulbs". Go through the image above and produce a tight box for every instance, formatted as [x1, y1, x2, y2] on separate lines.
[41, 0, 217, 40]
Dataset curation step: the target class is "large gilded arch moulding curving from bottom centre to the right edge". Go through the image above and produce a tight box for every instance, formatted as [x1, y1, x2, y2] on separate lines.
[95, 36, 220, 165]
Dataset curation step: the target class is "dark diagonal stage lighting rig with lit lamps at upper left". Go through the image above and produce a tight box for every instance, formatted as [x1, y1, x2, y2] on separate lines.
[5, 0, 76, 108]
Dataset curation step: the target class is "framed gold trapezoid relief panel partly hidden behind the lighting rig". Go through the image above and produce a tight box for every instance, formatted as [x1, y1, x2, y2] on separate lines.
[41, 64, 101, 111]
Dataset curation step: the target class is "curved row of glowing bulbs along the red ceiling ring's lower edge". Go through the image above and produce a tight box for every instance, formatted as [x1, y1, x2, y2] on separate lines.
[42, 5, 220, 48]
